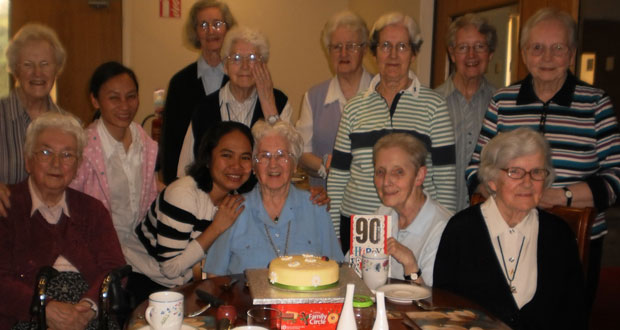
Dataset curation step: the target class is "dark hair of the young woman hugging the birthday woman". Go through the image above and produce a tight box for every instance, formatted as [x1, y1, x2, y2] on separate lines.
[187, 121, 254, 193]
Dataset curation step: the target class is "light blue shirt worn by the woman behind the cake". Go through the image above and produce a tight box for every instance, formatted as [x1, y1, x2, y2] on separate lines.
[204, 185, 344, 275]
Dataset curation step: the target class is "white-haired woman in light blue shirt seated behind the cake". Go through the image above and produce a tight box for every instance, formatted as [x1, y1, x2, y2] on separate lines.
[205, 120, 344, 275]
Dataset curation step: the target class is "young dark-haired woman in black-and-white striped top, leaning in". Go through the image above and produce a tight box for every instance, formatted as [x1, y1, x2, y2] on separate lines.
[133, 121, 254, 301]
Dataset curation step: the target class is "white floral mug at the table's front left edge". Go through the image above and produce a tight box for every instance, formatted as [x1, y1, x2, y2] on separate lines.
[144, 291, 183, 330]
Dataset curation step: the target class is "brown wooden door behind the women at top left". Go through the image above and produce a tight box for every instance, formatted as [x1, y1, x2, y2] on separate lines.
[9, 0, 122, 124]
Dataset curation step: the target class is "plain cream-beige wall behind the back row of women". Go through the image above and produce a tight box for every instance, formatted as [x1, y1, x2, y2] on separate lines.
[123, 0, 434, 127]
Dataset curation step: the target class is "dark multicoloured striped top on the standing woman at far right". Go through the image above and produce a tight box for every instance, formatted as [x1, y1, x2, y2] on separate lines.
[466, 72, 620, 238]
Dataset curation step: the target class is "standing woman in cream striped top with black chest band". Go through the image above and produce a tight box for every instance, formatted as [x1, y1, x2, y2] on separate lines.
[327, 13, 456, 251]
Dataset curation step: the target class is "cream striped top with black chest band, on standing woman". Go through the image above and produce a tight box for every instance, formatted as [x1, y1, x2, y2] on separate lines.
[327, 72, 456, 233]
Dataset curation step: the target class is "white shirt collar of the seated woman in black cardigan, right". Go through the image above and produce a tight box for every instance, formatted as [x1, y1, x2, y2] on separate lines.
[480, 196, 538, 240]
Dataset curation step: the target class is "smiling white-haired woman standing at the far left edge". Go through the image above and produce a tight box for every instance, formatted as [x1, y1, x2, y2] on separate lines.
[0, 24, 65, 199]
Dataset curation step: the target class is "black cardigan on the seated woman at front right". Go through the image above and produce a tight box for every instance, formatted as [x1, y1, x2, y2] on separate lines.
[433, 204, 586, 329]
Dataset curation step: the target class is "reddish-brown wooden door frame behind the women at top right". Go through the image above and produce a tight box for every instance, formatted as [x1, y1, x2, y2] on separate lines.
[431, 0, 579, 88]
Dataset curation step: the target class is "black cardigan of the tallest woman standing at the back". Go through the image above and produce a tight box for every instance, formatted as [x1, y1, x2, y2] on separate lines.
[159, 62, 228, 184]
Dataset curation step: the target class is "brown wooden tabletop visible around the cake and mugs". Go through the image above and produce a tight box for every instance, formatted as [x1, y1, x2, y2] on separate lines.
[127, 274, 509, 330]
